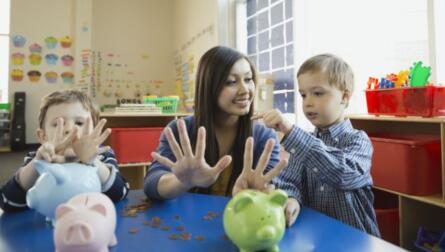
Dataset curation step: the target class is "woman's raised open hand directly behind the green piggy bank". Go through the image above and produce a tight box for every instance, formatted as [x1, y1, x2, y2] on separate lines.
[232, 137, 287, 196]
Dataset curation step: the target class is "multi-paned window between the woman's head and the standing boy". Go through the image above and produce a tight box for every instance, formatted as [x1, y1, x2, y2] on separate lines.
[237, 0, 295, 113]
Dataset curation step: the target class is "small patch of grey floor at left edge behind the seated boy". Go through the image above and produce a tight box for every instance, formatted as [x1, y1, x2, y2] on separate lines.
[0, 151, 28, 186]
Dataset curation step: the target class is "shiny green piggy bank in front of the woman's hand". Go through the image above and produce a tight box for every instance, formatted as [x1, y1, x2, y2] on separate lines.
[224, 190, 287, 252]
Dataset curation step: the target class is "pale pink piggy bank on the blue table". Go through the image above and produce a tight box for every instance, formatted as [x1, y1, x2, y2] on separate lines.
[54, 192, 117, 252]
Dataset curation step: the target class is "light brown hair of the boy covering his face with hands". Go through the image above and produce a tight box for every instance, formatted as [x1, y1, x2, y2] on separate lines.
[39, 89, 99, 129]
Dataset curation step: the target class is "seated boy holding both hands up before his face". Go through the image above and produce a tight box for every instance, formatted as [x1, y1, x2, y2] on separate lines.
[0, 90, 129, 212]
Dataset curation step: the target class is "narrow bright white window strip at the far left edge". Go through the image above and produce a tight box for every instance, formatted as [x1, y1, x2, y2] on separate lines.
[0, 0, 10, 103]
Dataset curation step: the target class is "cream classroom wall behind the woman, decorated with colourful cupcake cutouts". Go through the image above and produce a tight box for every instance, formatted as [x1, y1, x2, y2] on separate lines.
[9, 0, 221, 143]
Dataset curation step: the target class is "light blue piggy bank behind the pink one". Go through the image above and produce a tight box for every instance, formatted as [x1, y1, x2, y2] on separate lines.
[26, 160, 101, 224]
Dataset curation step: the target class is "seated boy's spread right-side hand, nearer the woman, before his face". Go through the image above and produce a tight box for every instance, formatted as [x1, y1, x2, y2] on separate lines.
[72, 118, 111, 164]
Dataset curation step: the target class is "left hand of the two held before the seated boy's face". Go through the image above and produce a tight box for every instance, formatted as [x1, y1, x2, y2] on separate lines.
[36, 118, 77, 163]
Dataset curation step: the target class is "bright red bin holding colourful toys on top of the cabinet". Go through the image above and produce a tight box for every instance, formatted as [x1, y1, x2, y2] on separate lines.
[366, 86, 445, 117]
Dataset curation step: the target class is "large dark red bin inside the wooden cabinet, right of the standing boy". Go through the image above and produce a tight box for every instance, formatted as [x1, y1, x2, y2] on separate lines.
[370, 134, 442, 195]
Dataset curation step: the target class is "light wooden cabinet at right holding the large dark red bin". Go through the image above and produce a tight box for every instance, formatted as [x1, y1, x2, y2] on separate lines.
[348, 115, 445, 251]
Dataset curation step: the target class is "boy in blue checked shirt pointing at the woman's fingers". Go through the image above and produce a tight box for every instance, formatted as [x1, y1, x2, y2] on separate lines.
[252, 54, 380, 236]
